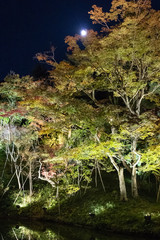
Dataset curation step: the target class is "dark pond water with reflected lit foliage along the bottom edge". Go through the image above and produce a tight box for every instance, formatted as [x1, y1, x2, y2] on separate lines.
[0, 222, 148, 240]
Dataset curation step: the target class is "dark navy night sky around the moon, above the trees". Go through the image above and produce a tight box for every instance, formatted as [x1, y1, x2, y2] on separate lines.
[0, 0, 160, 80]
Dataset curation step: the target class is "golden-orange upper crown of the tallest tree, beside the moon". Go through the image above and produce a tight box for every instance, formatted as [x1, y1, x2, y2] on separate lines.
[51, 1, 160, 116]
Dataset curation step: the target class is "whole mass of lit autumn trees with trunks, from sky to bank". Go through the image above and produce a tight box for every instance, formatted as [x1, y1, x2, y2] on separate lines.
[0, 0, 160, 204]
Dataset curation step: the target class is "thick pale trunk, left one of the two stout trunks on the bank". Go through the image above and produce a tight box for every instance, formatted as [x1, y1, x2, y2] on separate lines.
[118, 167, 128, 201]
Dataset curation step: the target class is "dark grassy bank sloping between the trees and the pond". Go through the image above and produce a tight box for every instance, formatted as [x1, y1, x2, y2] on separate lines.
[3, 189, 160, 237]
